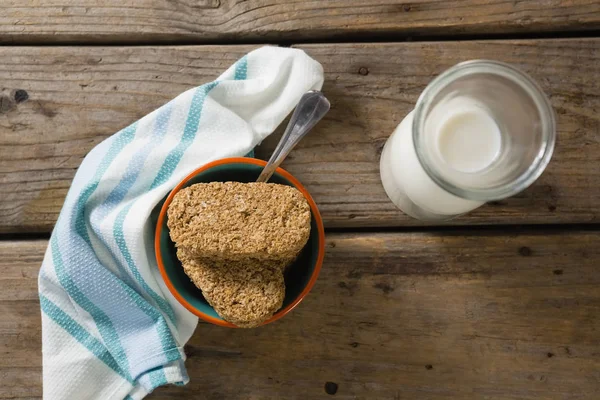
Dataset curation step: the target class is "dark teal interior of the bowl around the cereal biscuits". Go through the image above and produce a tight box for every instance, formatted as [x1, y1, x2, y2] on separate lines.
[157, 163, 319, 320]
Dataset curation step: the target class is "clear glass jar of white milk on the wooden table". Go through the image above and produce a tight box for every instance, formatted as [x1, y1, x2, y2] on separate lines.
[380, 60, 556, 221]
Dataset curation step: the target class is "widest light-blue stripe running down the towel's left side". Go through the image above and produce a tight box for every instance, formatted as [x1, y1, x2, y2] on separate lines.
[52, 121, 177, 374]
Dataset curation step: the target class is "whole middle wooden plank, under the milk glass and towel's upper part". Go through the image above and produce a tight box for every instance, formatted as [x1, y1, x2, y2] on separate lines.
[0, 39, 600, 232]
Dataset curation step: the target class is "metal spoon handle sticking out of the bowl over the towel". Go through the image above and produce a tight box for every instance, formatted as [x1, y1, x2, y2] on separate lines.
[256, 90, 330, 182]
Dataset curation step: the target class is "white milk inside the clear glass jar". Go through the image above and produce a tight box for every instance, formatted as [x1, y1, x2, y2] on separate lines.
[380, 97, 502, 220]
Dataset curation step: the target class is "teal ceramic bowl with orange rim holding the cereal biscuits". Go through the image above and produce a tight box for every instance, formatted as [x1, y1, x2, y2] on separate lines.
[154, 157, 325, 328]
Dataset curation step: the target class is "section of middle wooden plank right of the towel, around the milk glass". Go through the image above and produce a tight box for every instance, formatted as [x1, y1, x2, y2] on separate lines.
[282, 39, 600, 227]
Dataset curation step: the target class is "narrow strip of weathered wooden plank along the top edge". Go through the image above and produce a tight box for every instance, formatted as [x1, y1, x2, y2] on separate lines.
[0, 0, 600, 44]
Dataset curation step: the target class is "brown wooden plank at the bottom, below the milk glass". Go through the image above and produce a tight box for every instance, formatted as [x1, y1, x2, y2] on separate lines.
[0, 229, 600, 400]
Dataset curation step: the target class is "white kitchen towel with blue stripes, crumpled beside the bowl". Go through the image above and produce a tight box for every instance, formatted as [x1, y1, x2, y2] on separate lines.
[39, 47, 323, 400]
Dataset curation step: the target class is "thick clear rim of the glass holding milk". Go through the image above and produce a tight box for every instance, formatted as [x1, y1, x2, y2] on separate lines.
[412, 60, 556, 202]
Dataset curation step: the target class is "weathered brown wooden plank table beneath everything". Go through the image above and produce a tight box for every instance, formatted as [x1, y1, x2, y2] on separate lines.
[0, 0, 600, 400]
